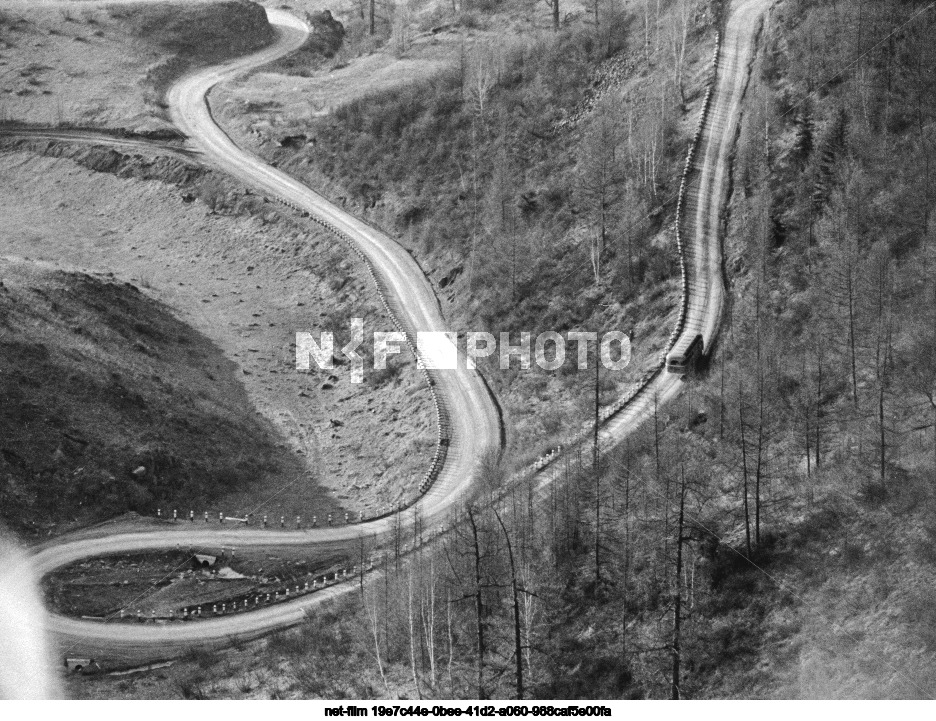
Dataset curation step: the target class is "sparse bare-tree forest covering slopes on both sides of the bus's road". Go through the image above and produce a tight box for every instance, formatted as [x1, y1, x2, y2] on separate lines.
[239, 0, 936, 698]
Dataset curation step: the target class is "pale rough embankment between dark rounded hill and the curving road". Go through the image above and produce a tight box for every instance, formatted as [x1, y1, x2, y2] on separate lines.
[0, 141, 435, 536]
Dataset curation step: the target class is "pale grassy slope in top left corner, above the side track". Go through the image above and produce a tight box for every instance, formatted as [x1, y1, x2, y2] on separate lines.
[0, 0, 273, 130]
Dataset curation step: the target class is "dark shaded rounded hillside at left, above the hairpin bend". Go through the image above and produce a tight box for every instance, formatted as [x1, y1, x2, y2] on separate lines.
[0, 262, 289, 534]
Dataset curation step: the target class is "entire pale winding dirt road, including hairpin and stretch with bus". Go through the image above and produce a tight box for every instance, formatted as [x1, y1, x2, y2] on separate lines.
[20, 0, 772, 664]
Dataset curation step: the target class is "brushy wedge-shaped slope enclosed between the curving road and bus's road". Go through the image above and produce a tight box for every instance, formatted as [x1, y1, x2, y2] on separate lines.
[213, 3, 724, 470]
